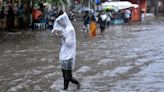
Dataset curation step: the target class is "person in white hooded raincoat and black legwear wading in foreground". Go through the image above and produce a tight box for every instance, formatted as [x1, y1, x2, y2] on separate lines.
[52, 12, 80, 90]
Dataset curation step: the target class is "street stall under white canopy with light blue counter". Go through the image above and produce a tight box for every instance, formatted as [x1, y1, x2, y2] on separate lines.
[102, 1, 139, 25]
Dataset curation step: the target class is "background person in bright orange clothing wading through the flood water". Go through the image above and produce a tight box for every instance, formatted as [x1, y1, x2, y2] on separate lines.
[89, 15, 96, 37]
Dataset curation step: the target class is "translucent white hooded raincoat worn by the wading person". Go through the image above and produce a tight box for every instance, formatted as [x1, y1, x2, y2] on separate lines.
[52, 13, 76, 68]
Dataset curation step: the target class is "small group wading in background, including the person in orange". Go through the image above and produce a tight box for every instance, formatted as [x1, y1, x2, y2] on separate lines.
[83, 11, 111, 37]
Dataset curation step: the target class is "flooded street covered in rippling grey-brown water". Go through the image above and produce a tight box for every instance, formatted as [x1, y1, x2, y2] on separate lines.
[0, 22, 164, 92]
